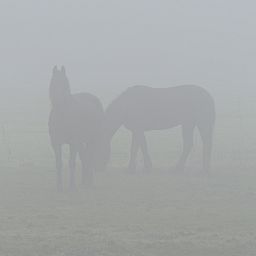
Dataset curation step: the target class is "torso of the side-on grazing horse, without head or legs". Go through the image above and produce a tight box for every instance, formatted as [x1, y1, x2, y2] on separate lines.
[112, 85, 215, 130]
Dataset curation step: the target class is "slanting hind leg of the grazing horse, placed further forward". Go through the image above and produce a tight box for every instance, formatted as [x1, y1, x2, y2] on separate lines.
[175, 124, 195, 171]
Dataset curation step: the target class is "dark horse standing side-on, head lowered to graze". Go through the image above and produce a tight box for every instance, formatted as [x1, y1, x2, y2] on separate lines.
[101, 85, 215, 171]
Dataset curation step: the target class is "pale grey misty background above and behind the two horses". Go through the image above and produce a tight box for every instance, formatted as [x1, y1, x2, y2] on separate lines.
[0, 0, 256, 170]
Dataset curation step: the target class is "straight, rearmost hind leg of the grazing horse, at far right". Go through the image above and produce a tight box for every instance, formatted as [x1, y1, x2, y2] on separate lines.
[198, 123, 213, 172]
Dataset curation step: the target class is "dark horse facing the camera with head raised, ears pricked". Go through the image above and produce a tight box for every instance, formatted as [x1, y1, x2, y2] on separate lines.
[49, 66, 104, 189]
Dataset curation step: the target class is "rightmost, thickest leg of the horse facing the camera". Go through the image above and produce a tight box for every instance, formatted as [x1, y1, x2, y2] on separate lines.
[78, 145, 93, 186]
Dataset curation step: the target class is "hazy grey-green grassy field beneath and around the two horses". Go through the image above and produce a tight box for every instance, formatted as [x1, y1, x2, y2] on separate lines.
[0, 93, 256, 256]
